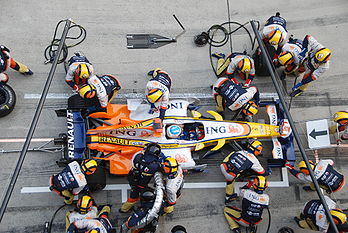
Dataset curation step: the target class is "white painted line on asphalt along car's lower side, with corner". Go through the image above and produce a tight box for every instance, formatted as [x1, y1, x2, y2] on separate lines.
[21, 167, 289, 202]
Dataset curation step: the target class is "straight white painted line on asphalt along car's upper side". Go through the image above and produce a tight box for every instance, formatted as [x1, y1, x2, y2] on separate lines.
[24, 93, 278, 99]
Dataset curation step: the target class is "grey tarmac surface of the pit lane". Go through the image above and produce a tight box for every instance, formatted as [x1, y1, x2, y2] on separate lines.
[0, 0, 348, 233]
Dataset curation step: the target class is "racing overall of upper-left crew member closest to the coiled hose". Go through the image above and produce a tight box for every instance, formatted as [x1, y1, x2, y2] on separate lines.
[65, 55, 93, 91]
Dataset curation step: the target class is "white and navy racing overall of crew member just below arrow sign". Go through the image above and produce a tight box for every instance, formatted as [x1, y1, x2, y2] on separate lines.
[290, 159, 345, 193]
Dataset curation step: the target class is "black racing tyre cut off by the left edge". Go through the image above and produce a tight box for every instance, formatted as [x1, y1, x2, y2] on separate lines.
[0, 83, 16, 117]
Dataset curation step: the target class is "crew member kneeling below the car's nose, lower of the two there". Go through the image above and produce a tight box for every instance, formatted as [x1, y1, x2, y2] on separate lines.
[224, 176, 269, 233]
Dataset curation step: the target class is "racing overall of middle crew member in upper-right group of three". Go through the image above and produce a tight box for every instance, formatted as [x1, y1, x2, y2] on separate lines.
[281, 38, 304, 74]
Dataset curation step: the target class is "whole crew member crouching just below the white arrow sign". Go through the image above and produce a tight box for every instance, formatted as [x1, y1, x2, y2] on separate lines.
[285, 159, 345, 194]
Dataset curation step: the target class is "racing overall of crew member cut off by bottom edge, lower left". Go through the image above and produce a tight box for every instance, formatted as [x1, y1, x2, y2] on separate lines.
[67, 206, 112, 233]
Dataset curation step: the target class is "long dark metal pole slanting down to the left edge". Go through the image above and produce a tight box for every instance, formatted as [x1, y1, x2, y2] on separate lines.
[0, 19, 71, 223]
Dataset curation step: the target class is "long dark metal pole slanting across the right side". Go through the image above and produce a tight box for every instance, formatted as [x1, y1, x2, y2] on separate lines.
[250, 20, 339, 233]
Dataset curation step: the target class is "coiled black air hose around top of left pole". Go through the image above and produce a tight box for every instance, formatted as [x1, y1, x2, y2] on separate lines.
[44, 20, 87, 64]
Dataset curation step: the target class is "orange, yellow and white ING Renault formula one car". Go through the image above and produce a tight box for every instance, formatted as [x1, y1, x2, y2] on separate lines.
[56, 95, 293, 175]
